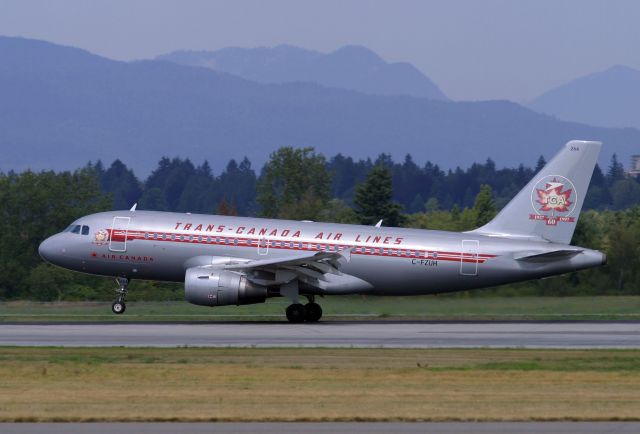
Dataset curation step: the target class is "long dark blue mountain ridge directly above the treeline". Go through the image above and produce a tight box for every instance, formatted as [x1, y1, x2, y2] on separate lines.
[0, 37, 640, 175]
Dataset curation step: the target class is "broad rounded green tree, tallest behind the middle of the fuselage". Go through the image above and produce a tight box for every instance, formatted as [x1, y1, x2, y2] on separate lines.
[257, 147, 331, 220]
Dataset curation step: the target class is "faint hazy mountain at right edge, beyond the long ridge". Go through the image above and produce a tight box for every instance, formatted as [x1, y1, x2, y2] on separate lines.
[528, 66, 640, 128]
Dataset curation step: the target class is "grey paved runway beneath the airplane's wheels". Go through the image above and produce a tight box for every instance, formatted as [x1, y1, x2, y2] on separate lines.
[0, 321, 640, 349]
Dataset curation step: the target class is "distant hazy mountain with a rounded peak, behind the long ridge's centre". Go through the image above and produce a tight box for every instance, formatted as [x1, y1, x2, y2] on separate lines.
[156, 45, 447, 100]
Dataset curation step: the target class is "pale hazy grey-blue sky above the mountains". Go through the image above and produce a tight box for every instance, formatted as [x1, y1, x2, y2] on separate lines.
[0, 0, 640, 102]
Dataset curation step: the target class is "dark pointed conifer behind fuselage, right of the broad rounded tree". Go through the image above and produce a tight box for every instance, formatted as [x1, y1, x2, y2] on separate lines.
[354, 165, 404, 226]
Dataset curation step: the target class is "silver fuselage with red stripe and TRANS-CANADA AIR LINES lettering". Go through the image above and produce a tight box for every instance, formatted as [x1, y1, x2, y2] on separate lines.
[40, 211, 605, 295]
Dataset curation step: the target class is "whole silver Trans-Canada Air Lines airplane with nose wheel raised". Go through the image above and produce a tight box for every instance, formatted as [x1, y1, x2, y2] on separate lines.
[39, 140, 606, 323]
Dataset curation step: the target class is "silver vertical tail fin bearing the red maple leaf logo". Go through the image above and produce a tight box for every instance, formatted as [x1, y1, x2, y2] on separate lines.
[471, 140, 602, 244]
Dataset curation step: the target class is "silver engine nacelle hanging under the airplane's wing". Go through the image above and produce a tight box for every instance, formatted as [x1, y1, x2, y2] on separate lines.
[184, 267, 267, 306]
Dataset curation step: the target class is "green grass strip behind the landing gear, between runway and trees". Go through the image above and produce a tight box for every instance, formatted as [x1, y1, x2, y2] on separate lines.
[0, 296, 640, 322]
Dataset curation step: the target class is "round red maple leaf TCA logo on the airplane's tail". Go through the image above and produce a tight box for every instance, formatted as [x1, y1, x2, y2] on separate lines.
[529, 175, 577, 226]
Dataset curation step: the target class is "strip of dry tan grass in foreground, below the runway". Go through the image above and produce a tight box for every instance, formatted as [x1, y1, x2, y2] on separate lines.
[0, 348, 640, 421]
